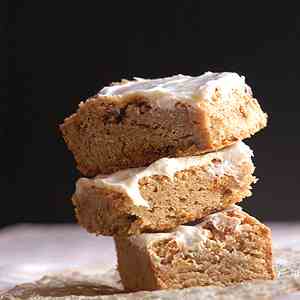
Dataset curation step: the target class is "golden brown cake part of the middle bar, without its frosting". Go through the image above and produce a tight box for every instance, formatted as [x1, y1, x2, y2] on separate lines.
[73, 161, 256, 235]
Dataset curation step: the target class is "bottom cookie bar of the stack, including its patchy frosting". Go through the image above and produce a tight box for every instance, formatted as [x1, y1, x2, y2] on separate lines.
[115, 206, 275, 291]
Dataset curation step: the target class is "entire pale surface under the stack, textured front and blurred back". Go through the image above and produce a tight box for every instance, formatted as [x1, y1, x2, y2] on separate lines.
[0, 223, 300, 300]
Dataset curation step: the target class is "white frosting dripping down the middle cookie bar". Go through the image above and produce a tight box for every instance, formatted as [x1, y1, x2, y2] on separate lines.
[76, 142, 253, 208]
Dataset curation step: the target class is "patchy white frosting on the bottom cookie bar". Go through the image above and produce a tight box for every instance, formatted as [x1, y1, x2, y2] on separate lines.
[129, 205, 242, 258]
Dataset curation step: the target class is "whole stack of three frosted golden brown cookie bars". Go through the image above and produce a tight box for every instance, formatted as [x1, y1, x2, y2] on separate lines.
[61, 72, 275, 291]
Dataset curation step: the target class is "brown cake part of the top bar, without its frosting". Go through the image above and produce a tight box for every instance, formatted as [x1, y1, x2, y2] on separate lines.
[60, 93, 267, 176]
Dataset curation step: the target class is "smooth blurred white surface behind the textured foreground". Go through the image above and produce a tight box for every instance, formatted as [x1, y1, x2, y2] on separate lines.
[0, 223, 300, 300]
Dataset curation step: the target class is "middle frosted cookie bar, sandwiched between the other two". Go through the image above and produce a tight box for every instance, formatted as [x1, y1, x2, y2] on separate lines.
[72, 142, 256, 235]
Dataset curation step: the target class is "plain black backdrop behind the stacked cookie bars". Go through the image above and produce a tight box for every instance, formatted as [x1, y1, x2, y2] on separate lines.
[4, 1, 300, 226]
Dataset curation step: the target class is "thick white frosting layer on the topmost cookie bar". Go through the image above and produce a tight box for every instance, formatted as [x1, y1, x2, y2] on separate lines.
[98, 72, 251, 102]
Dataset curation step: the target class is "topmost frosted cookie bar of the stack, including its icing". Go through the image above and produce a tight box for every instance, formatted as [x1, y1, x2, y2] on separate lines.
[60, 72, 267, 176]
